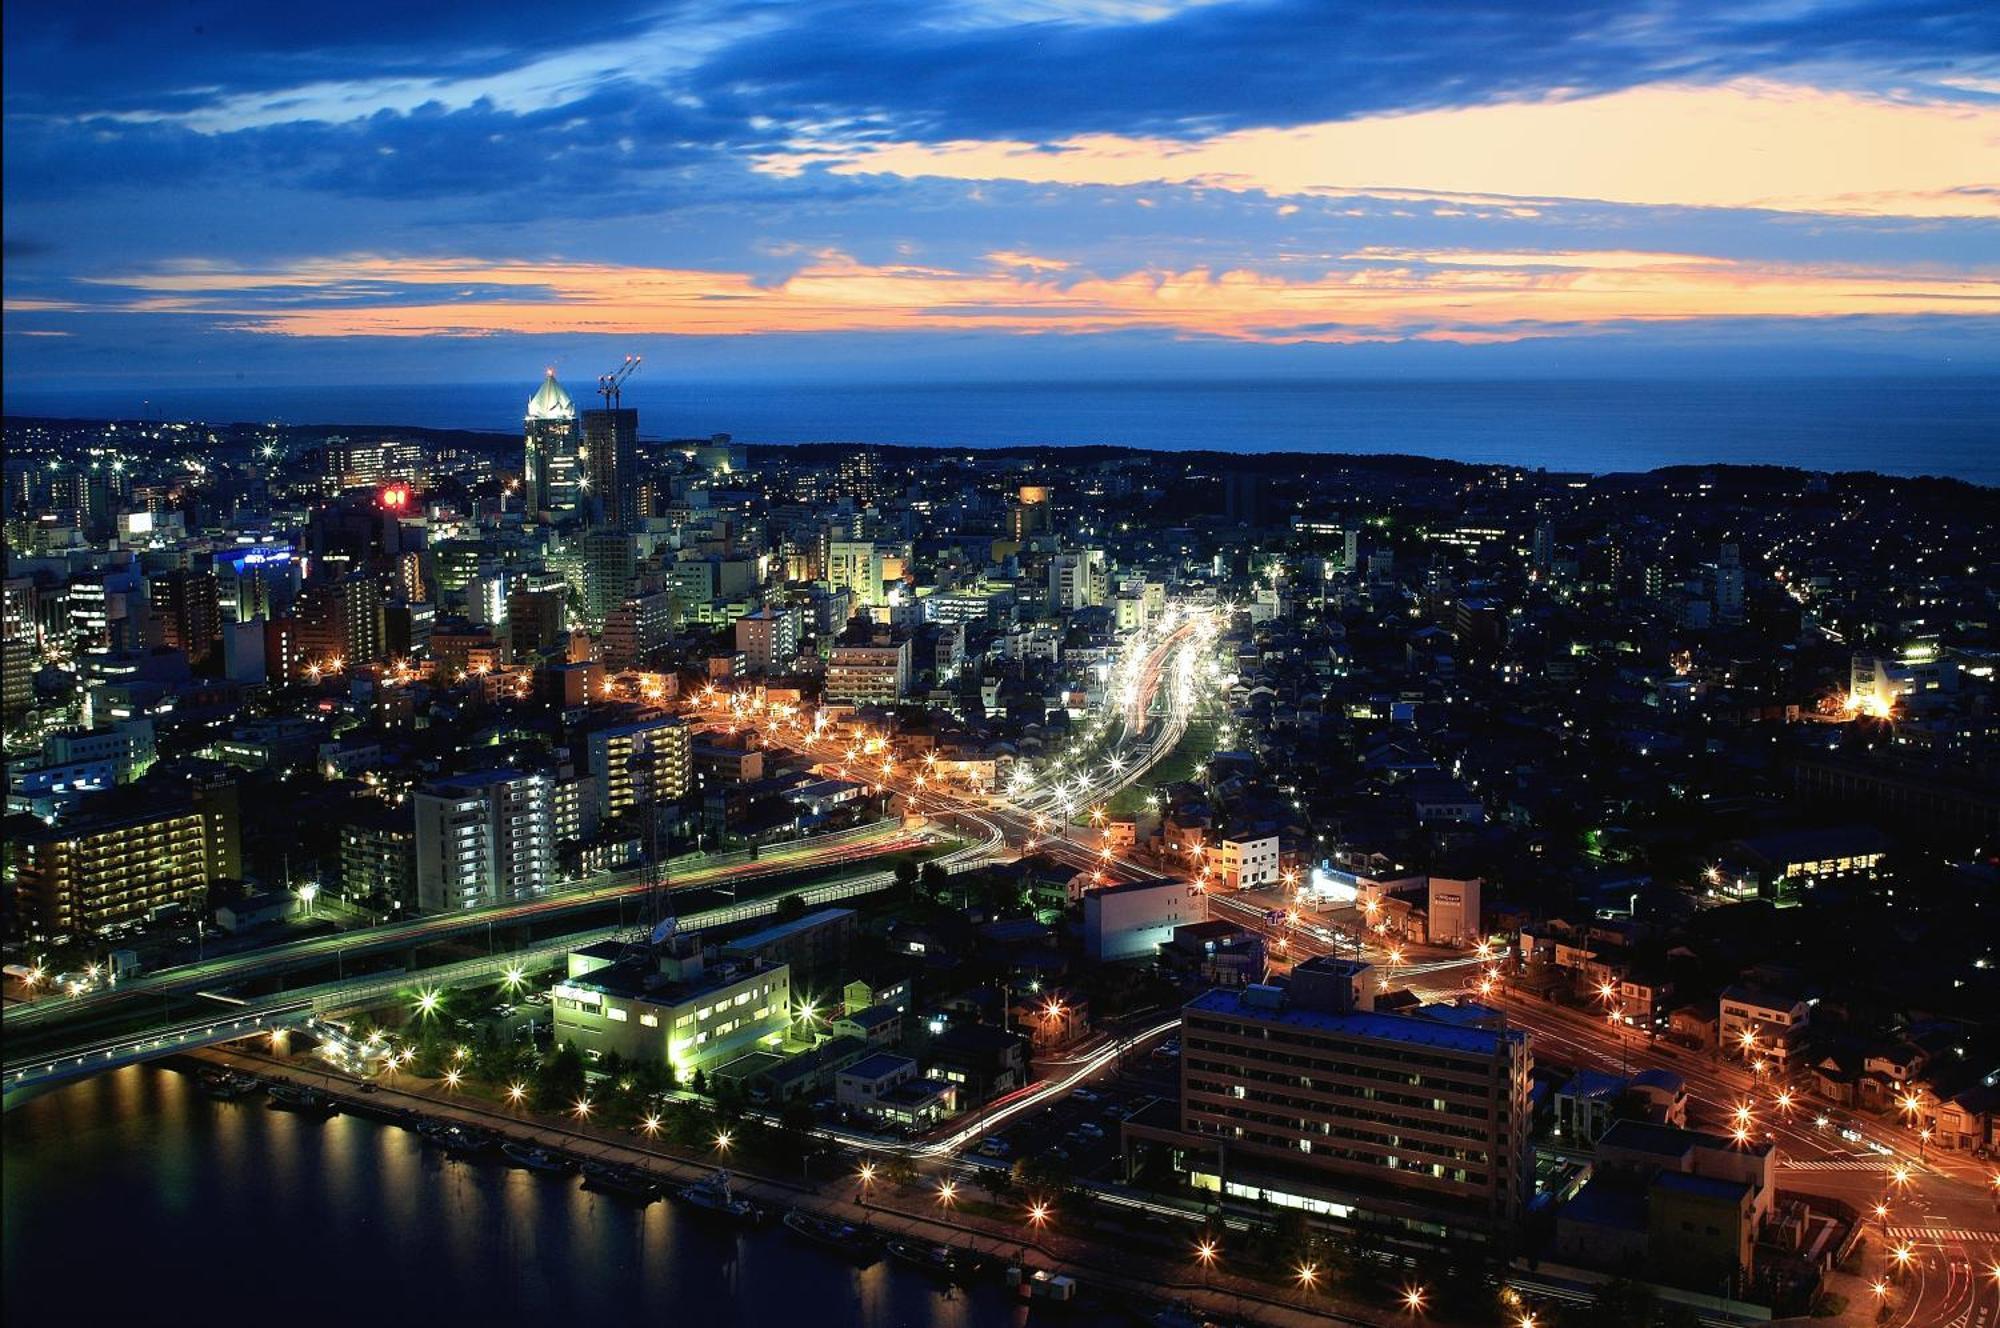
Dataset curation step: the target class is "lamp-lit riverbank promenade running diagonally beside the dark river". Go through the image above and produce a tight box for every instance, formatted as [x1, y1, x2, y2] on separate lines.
[198, 1048, 1396, 1328]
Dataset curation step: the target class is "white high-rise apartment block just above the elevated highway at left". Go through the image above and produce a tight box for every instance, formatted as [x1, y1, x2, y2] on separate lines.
[412, 770, 556, 912]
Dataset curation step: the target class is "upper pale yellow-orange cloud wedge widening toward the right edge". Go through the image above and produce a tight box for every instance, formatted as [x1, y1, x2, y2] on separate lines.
[758, 82, 2000, 216]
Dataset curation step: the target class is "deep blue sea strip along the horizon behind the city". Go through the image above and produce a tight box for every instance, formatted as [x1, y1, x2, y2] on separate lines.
[6, 376, 2000, 484]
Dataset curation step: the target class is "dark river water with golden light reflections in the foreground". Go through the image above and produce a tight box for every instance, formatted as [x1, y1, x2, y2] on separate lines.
[0, 1066, 1048, 1328]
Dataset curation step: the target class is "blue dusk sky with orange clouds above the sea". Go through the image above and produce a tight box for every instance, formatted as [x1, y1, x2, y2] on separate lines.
[4, 0, 2000, 388]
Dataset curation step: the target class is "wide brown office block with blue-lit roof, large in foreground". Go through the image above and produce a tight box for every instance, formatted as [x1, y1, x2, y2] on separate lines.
[1134, 956, 1534, 1236]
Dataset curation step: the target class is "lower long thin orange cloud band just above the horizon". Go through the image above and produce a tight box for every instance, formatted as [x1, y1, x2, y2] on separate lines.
[54, 248, 2000, 342]
